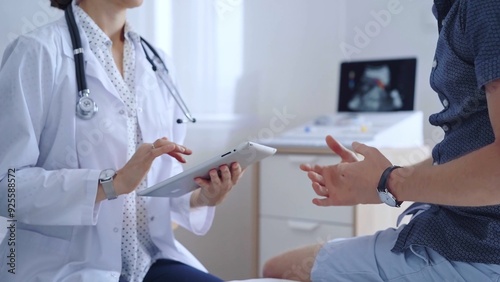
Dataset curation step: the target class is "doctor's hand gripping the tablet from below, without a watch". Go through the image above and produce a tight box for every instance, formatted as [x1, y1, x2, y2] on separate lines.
[190, 163, 243, 208]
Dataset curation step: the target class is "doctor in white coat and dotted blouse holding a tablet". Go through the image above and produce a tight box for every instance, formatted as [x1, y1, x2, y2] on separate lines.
[0, 0, 242, 282]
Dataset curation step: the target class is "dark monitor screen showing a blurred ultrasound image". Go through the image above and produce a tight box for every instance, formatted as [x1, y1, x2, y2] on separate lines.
[338, 58, 417, 112]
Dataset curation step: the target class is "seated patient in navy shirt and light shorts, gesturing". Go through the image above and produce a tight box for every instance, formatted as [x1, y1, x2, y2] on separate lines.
[263, 0, 500, 281]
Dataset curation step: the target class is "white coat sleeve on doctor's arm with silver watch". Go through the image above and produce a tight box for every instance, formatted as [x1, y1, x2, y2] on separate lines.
[0, 37, 92, 225]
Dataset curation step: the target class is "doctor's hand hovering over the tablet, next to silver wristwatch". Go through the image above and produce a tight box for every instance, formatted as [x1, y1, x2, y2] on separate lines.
[96, 137, 192, 202]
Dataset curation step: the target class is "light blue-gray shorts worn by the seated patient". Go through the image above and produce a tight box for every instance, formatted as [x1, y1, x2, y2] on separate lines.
[311, 225, 500, 282]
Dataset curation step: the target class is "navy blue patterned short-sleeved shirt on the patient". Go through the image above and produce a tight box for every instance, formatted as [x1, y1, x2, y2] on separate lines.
[393, 0, 500, 264]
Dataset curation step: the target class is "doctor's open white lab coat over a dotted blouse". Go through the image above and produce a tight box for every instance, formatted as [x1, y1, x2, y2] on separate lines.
[0, 12, 214, 282]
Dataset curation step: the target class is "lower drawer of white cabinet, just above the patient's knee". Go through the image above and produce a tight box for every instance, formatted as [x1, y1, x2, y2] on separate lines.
[259, 217, 353, 275]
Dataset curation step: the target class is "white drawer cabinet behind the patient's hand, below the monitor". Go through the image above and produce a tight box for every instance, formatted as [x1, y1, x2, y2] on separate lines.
[259, 147, 429, 273]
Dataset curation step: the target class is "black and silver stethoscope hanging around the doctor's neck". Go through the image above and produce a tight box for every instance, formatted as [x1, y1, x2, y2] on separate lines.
[64, 4, 196, 123]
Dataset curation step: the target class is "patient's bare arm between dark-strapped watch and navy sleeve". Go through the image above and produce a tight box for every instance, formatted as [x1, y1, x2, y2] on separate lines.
[389, 80, 500, 206]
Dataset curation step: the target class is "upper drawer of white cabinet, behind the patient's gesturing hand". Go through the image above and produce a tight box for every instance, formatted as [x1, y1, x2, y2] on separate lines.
[259, 154, 354, 224]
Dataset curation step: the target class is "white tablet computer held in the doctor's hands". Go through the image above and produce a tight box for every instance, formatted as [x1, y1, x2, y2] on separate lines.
[137, 141, 276, 197]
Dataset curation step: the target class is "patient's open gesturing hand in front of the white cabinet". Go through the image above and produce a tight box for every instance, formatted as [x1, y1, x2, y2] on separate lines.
[300, 136, 391, 206]
